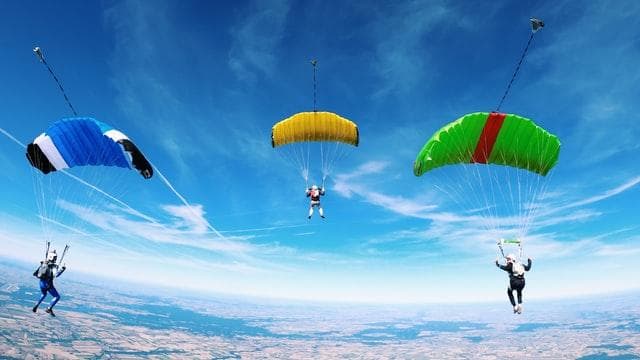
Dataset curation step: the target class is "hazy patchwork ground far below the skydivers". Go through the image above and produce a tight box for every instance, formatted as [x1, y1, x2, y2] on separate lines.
[0, 262, 640, 359]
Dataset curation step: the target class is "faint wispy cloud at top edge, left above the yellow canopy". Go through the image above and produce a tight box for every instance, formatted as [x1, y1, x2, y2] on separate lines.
[228, 0, 289, 83]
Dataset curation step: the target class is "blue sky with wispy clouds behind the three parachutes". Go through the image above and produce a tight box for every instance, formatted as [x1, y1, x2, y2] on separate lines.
[0, 1, 640, 302]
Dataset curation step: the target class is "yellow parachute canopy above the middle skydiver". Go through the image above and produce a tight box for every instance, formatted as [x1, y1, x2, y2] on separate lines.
[271, 111, 359, 148]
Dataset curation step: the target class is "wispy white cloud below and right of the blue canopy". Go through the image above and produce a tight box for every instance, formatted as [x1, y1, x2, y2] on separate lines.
[45, 200, 320, 273]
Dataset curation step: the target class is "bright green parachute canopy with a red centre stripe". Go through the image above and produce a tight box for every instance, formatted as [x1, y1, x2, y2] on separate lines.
[413, 112, 560, 176]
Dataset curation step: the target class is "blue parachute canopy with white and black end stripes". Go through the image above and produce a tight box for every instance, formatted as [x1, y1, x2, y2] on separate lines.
[26, 118, 153, 179]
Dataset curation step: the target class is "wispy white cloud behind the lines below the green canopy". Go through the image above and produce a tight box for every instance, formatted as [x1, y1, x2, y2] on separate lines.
[334, 161, 640, 258]
